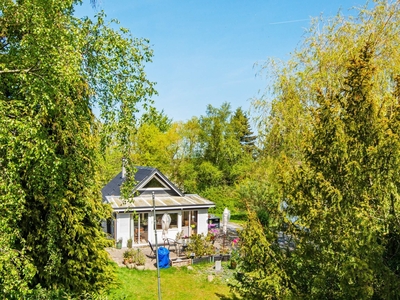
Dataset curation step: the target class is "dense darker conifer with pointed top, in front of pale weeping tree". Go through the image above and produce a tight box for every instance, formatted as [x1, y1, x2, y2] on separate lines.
[286, 43, 400, 299]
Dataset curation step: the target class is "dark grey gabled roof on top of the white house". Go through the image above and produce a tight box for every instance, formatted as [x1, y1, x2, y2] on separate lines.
[101, 167, 183, 199]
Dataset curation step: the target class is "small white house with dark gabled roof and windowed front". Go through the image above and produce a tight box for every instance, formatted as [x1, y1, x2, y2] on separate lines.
[102, 167, 215, 247]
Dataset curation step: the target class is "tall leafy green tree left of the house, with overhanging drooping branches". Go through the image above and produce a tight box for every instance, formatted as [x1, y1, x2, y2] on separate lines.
[0, 0, 154, 299]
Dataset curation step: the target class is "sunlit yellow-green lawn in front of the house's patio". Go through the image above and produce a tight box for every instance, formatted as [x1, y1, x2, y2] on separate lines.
[108, 264, 239, 300]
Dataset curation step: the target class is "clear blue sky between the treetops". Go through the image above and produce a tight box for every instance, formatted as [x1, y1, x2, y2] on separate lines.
[76, 0, 365, 121]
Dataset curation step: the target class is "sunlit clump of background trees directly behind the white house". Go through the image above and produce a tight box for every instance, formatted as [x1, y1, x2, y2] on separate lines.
[130, 103, 256, 212]
